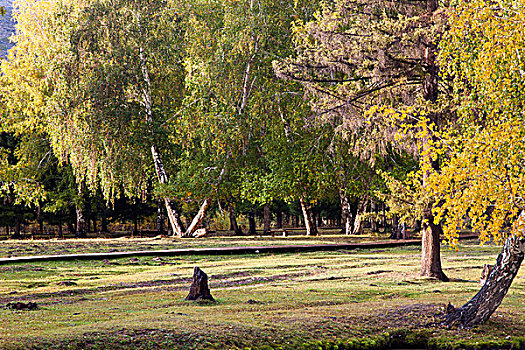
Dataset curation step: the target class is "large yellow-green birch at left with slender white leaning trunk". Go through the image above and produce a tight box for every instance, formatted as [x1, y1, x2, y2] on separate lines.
[3, 0, 218, 236]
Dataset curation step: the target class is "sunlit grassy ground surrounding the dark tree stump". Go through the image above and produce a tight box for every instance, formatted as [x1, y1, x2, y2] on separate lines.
[0, 237, 525, 349]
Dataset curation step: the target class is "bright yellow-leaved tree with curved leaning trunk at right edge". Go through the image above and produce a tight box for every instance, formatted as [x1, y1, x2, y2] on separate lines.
[430, 0, 525, 327]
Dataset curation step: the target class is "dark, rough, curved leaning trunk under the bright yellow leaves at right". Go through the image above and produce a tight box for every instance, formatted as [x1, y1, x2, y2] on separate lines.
[443, 236, 525, 328]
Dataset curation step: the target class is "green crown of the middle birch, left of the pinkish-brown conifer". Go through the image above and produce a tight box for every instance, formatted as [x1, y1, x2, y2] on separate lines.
[181, 0, 322, 235]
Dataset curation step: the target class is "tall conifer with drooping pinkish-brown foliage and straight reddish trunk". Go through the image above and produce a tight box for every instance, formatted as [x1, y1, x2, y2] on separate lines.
[276, 0, 448, 281]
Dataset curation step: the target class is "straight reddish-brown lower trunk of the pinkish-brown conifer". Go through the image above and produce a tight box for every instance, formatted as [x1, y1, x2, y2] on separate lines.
[421, 208, 449, 282]
